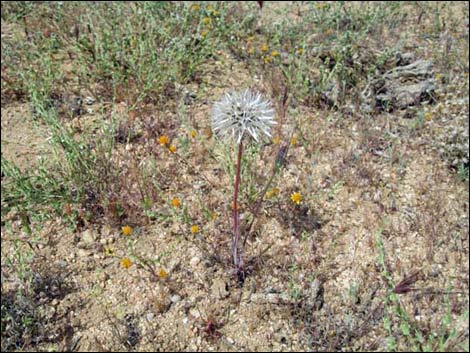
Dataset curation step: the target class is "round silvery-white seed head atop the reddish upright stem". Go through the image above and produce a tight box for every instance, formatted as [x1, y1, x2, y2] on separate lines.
[212, 89, 276, 143]
